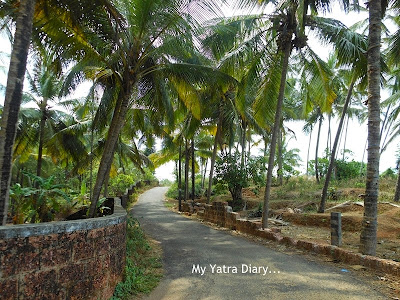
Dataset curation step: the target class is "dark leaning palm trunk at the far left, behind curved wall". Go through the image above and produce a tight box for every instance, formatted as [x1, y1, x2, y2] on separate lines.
[0, 0, 36, 225]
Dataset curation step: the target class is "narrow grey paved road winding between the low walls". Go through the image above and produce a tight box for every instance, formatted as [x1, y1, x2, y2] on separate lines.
[133, 187, 386, 300]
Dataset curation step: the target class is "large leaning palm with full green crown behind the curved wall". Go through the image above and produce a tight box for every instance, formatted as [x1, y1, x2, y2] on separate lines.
[41, 0, 223, 215]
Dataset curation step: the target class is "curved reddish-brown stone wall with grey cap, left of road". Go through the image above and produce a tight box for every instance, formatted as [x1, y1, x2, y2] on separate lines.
[0, 198, 127, 300]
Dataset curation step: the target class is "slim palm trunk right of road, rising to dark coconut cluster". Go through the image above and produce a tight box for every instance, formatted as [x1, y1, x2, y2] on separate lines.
[262, 42, 292, 228]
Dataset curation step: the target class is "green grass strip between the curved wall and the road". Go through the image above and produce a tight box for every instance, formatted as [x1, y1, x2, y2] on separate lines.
[111, 217, 163, 300]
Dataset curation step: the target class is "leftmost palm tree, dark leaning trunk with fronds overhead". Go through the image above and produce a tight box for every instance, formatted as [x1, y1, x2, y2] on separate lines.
[0, 0, 121, 223]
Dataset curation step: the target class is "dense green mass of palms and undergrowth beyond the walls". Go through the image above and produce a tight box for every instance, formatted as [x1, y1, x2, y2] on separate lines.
[0, 0, 400, 260]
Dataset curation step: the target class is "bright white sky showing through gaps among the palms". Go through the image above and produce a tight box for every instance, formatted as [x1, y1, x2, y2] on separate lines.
[0, 5, 399, 180]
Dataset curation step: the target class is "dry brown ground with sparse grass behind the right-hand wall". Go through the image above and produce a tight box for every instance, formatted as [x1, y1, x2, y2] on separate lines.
[241, 188, 400, 262]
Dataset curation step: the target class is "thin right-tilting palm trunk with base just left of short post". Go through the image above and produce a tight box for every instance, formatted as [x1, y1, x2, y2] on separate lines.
[318, 79, 355, 213]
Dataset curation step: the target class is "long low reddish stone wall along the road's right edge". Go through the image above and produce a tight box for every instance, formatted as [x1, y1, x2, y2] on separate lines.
[193, 202, 400, 276]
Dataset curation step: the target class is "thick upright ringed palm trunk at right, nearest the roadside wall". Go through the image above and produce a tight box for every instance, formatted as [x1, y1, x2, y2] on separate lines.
[360, 0, 382, 255]
